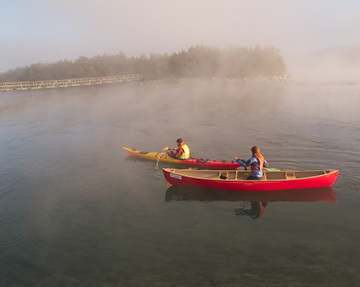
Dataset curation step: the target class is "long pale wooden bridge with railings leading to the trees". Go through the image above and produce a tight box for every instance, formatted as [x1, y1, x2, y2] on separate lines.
[0, 74, 147, 92]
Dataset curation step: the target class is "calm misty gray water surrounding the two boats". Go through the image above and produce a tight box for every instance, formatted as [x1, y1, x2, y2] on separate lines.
[0, 81, 360, 287]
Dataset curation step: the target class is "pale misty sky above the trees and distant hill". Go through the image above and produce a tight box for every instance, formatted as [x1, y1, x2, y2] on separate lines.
[0, 0, 360, 72]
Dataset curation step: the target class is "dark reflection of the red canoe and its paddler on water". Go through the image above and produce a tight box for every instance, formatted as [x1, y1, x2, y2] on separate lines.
[165, 186, 336, 219]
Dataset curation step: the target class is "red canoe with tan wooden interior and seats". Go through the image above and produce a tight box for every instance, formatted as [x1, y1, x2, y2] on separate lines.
[163, 168, 338, 191]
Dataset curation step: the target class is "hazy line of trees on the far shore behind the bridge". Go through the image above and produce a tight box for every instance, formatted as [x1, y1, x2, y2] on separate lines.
[0, 45, 286, 82]
